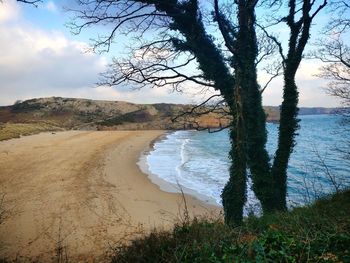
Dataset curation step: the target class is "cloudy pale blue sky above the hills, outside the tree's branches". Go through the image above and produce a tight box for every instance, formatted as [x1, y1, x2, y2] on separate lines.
[0, 0, 340, 107]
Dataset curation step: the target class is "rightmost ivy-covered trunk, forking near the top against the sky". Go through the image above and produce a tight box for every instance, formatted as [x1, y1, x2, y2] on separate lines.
[271, 0, 327, 211]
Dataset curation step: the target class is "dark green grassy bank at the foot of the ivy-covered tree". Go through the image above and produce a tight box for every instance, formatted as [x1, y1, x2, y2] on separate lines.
[112, 191, 350, 262]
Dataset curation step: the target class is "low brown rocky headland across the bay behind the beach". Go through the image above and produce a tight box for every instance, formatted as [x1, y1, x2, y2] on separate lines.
[0, 97, 335, 134]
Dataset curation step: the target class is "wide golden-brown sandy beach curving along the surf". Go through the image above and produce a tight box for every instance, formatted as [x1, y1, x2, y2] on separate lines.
[0, 131, 219, 262]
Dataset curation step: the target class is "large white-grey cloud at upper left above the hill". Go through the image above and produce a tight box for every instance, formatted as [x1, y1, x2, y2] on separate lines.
[0, 1, 106, 105]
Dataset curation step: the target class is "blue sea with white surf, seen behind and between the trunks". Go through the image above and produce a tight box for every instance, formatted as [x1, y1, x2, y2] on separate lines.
[145, 115, 350, 214]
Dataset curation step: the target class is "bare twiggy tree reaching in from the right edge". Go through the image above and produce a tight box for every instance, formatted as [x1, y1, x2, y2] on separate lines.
[312, 0, 350, 168]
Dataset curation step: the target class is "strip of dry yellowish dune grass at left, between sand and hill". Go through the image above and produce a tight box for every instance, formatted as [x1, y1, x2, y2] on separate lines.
[0, 122, 62, 141]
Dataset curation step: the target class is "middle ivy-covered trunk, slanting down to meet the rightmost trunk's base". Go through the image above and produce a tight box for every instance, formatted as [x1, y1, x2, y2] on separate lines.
[235, 1, 274, 216]
